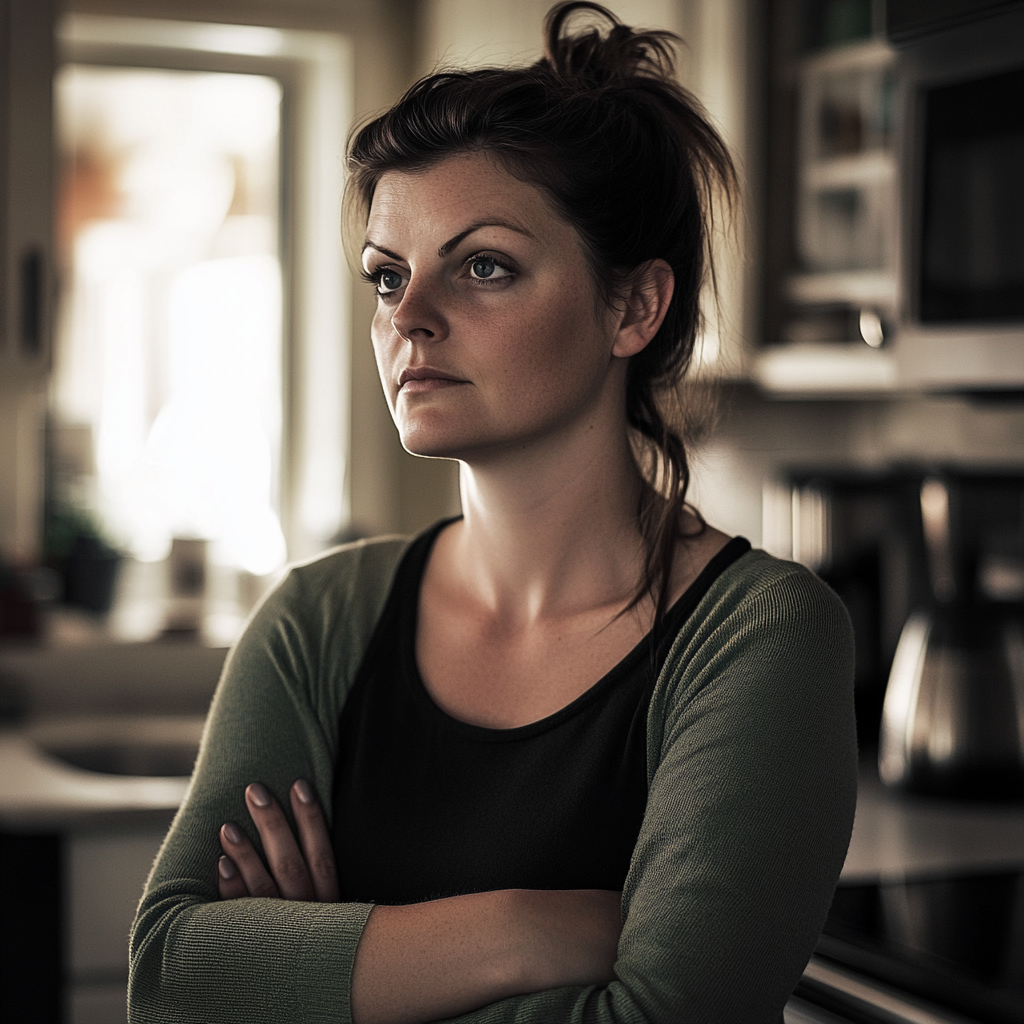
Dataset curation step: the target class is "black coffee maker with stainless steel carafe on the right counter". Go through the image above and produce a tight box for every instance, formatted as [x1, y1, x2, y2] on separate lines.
[763, 466, 1024, 798]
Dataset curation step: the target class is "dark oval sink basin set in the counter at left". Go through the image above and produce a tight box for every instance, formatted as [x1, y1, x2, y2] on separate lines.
[28, 715, 204, 777]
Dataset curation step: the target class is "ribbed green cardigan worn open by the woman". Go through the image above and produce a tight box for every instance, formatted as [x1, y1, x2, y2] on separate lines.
[129, 539, 856, 1024]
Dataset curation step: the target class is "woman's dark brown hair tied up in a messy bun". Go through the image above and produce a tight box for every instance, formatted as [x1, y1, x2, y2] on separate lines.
[346, 2, 736, 616]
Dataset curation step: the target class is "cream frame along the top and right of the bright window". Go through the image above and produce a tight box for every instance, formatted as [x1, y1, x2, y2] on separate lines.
[55, 14, 354, 561]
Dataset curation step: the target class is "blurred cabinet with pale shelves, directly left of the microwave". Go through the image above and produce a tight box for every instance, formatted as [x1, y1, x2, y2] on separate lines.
[752, 0, 899, 397]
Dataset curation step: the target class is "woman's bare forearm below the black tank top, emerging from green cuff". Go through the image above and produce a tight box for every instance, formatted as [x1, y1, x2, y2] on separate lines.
[351, 890, 620, 1024]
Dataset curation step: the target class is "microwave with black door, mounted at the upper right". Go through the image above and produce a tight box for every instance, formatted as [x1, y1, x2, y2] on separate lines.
[886, 0, 1024, 392]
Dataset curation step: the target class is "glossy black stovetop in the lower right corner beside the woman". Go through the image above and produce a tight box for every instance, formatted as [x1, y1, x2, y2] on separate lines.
[817, 870, 1024, 1024]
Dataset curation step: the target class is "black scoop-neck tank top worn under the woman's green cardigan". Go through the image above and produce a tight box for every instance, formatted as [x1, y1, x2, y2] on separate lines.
[333, 520, 751, 904]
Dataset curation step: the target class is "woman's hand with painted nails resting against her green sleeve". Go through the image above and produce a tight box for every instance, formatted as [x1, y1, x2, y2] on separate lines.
[217, 778, 338, 903]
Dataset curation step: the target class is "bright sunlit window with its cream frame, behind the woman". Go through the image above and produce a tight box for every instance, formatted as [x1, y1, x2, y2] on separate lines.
[47, 13, 352, 643]
